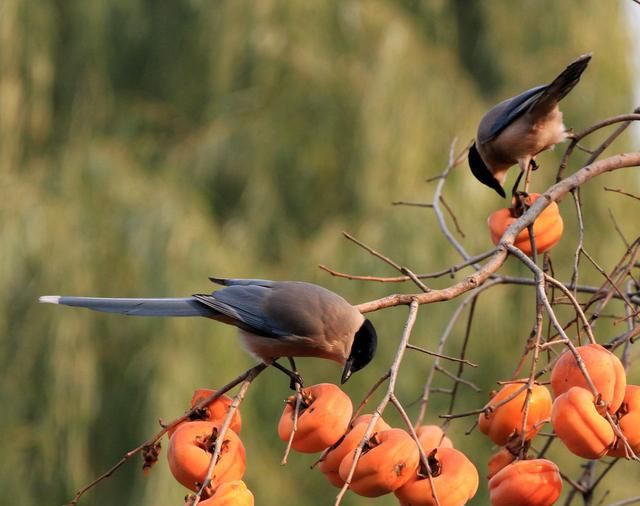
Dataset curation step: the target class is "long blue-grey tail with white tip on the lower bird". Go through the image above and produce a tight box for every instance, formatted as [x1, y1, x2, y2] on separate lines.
[40, 295, 214, 316]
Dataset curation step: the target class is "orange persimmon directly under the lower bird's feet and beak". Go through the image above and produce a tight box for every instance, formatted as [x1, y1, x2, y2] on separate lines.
[278, 383, 353, 453]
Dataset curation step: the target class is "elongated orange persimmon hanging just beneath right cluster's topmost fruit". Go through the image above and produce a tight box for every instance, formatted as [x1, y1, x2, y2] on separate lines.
[551, 387, 615, 459]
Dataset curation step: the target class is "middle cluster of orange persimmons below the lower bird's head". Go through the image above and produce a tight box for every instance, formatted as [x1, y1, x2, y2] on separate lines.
[278, 383, 478, 506]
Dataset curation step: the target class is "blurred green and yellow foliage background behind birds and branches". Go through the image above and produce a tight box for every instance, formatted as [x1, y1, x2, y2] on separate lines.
[0, 0, 640, 506]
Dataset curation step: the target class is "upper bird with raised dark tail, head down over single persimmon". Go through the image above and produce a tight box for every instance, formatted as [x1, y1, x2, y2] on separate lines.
[469, 53, 591, 197]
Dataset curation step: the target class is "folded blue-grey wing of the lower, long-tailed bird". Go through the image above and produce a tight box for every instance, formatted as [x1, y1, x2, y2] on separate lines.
[194, 286, 290, 338]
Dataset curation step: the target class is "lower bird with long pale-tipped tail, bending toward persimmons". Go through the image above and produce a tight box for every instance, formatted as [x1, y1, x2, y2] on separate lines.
[40, 278, 378, 383]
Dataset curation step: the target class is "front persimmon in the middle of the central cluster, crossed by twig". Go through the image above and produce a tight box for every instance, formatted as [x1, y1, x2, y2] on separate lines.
[338, 429, 420, 497]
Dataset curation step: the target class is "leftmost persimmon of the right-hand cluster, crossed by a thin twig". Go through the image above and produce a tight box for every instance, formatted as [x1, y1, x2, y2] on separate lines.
[478, 383, 551, 446]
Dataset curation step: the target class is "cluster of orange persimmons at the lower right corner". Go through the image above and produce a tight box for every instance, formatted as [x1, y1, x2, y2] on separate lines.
[478, 344, 640, 506]
